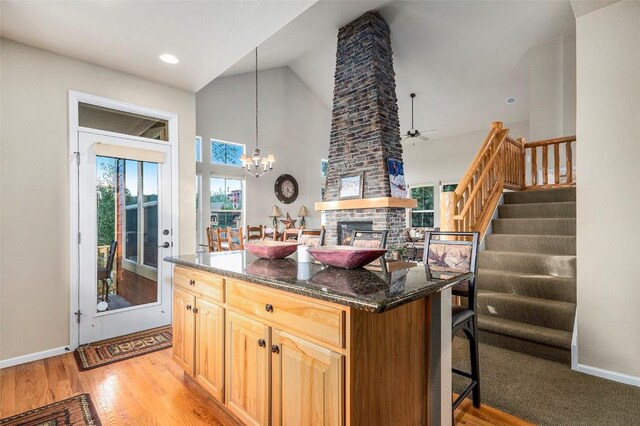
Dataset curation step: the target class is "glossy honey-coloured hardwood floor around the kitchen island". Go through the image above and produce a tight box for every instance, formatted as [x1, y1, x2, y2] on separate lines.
[0, 349, 529, 426]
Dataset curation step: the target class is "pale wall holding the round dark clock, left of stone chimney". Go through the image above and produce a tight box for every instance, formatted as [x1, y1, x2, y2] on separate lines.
[196, 67, 331, 241]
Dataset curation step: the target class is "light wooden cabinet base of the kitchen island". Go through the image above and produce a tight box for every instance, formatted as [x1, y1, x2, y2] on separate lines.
[173, 267, 430, 426]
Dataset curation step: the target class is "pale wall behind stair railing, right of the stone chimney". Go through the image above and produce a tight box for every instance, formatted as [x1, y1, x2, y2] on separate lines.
[402, 121, 529, 226]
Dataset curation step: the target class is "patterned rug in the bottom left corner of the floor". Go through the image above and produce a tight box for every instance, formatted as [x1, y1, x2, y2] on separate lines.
[0, 393, 102, 426]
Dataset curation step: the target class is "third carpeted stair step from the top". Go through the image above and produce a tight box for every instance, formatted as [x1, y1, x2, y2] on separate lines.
[491, 218, 576, 235]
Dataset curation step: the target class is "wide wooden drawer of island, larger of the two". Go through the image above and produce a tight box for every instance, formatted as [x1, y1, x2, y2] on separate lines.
[227, 279, 345, 347]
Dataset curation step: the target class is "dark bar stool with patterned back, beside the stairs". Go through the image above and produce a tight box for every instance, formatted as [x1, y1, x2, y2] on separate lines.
[423, 231, 480, 410]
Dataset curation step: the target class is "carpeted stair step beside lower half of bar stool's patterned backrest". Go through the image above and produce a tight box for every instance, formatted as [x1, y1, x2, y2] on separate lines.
[478, 250, 576, 277]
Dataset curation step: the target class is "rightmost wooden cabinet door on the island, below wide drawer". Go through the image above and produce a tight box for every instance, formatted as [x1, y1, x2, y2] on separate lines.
[271, 330, 344, 426]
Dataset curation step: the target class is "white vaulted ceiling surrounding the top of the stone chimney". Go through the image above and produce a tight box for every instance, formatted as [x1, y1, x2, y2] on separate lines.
[0, 0, 575, 138]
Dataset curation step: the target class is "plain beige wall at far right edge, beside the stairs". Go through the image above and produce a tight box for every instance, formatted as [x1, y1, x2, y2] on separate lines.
[577, 1, 640, 385]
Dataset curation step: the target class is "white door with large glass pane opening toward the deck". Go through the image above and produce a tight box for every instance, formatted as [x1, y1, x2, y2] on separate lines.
[78, 131, 173, 344]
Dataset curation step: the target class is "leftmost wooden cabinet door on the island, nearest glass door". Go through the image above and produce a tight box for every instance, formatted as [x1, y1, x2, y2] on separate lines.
[173, 288, 196, 377]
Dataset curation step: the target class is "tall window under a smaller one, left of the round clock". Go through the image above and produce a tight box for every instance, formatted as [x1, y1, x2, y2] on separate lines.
[211, 177, 244, 228]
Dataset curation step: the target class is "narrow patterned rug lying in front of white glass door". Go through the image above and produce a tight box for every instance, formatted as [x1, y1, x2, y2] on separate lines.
[74, 326, 172, 371]
